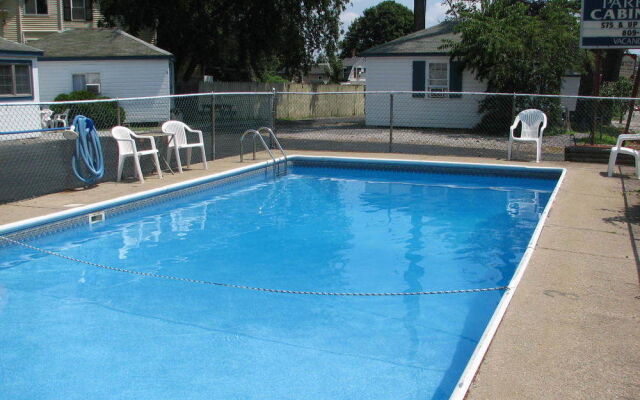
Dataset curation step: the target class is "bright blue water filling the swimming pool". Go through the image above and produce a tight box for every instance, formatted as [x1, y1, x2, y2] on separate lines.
[0, 161, 556, 400]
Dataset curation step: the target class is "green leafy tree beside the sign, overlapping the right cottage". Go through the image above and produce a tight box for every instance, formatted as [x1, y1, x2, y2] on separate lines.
[447, 0, 586, 133]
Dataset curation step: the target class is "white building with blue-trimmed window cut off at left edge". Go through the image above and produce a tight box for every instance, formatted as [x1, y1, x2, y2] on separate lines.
[0, 38, 42, 136]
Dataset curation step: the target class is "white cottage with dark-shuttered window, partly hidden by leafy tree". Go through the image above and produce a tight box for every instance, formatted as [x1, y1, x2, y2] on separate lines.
[360, 22, 579, 129]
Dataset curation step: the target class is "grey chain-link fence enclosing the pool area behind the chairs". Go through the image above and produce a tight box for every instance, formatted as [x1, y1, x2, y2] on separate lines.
[0, 91, 640, 203]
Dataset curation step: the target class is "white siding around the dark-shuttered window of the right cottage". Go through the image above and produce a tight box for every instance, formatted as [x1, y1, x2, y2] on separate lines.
[366, 57, 486, 129]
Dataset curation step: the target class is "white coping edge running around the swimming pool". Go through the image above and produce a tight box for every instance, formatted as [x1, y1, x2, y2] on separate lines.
[0, 155, 567, 400]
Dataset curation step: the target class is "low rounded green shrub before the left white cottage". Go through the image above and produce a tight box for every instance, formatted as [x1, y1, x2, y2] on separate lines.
[51, 90, 125, 129]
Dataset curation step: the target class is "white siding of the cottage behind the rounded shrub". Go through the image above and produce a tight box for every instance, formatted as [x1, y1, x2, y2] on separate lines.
[39, 59, 171, 122]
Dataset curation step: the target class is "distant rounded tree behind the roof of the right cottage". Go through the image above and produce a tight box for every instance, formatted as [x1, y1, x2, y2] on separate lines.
[340, 0, 413, 58]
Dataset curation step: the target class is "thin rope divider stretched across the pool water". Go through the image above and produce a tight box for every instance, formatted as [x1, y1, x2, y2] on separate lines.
[0, 235, 509, 296]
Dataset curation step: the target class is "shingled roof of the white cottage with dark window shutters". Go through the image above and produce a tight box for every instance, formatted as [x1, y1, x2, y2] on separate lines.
[359, 21, 460, 57]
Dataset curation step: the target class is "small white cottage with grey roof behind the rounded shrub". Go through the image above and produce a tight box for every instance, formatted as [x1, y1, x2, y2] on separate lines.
[33, 28, 173, 122]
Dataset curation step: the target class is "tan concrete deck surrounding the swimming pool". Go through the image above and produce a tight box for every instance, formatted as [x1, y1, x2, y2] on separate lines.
[0, 151, 640, 399]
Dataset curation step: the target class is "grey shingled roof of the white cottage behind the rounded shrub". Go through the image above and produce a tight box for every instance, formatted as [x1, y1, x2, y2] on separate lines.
[33, 28, 173, 60]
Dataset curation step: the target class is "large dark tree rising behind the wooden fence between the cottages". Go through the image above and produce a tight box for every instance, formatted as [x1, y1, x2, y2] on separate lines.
[99, 0, 349, 81]
